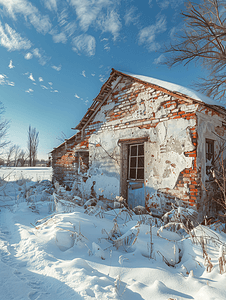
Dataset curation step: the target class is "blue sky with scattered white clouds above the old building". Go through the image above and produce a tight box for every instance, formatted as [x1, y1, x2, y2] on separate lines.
[0, 0, 205, 158]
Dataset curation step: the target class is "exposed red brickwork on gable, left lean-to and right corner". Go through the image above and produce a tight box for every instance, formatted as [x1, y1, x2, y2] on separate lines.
[52, 70, 225, 217]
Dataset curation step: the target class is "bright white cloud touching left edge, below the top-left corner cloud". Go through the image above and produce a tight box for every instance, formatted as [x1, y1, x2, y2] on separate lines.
[0, 22, 31, 51]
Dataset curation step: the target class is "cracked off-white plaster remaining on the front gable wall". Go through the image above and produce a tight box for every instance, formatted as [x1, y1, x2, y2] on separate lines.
[77, 78, 196, 207]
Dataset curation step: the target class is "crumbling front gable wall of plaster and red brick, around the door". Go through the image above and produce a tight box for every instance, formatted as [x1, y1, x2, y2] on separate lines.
[74, 77, 199, 213]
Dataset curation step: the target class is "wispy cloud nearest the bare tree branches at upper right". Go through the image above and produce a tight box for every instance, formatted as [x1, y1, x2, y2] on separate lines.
[138, 15, 166, 51]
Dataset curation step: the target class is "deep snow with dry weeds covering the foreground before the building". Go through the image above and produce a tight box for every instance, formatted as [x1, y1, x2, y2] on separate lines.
[0, 173, 226, 300]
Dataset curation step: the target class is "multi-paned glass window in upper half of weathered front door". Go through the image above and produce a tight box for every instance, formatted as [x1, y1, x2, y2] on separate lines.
[128, 144, 144, 180]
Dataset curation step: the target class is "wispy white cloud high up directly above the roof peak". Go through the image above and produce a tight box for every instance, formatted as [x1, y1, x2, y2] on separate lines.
[97, 10, 121, 41]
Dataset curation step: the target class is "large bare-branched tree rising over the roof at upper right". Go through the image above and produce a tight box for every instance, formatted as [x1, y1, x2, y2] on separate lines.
[165, 0, 226, 100]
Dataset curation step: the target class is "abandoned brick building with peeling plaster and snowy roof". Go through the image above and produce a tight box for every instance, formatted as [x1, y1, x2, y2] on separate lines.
[51, 69, 226, 215]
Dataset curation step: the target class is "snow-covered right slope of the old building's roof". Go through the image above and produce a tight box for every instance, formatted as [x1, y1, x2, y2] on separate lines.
[122, 72, 225, 108]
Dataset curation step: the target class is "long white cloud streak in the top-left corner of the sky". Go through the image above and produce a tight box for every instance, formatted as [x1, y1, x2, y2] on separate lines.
[0, 0, 52, 34]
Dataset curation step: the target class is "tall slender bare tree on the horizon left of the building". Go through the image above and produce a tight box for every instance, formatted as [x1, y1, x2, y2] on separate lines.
[27, 125, 39, 166]
